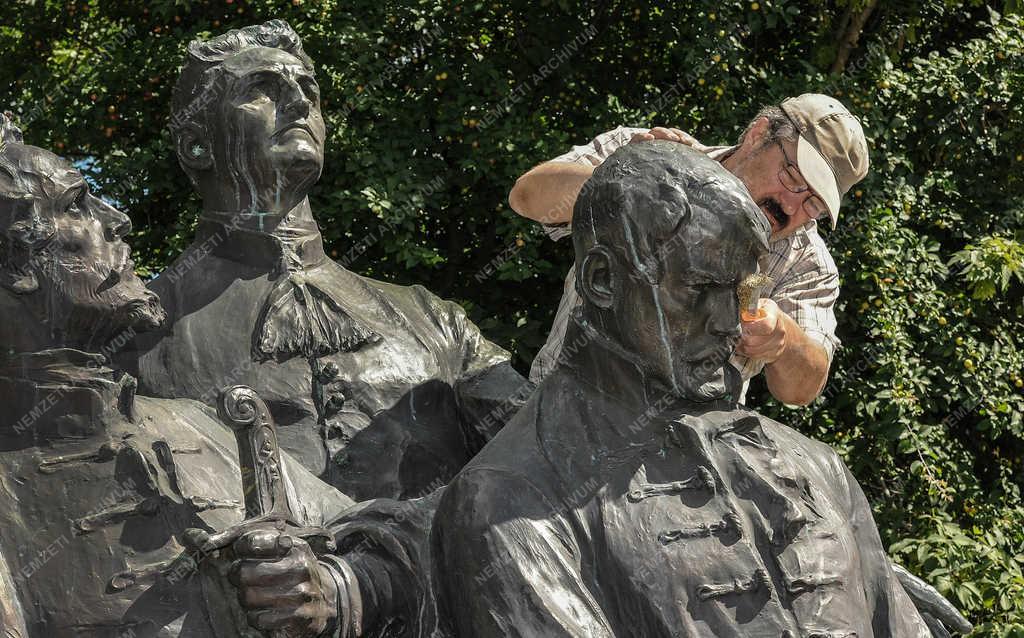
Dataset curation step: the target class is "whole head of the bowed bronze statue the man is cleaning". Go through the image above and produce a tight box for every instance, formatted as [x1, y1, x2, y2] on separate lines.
[572, 140, 770, 400]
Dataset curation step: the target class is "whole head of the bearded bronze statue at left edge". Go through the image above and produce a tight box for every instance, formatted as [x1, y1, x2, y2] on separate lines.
[0, 115, 164, 352]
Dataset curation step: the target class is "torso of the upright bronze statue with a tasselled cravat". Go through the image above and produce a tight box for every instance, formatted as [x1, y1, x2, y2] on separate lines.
[138, 222, 522, 500]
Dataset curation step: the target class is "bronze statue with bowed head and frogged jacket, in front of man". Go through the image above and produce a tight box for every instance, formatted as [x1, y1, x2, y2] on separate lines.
[433, 140, 929, 638]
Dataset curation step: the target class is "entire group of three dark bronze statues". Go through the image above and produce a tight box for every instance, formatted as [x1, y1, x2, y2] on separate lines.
[0, 20, 970, 638]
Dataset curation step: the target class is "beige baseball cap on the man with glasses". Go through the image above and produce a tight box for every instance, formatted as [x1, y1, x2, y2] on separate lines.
[780, 93, 869, 228]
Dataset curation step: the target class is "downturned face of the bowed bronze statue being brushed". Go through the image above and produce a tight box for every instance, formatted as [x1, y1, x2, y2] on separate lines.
[617, 187, 759, 401]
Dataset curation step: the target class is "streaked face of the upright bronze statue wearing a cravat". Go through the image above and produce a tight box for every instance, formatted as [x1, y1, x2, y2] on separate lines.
[208, 47, 327, 212]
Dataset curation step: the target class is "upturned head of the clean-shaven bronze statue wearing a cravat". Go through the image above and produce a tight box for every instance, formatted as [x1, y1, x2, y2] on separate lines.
[171, 19, 327, 216]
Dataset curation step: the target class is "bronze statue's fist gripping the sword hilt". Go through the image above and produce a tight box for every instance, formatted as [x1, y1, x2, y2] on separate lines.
[227, 529, 338, 638]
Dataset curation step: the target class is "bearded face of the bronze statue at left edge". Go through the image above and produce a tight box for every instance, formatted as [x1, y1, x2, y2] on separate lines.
[0, 145, 164, 346]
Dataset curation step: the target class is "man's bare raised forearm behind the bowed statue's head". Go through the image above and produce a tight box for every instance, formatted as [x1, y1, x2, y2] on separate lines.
[509, 162, 594, 223]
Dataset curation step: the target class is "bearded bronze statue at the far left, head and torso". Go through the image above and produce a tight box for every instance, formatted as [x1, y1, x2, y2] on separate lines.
[0, 116, 351, 638]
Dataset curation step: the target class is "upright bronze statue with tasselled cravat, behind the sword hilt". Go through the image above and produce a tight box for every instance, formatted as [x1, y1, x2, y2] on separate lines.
[131, 20, 523, 500]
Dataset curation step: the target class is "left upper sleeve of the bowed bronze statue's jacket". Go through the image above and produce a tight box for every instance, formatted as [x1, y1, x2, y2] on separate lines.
[434, 469, 614, 638]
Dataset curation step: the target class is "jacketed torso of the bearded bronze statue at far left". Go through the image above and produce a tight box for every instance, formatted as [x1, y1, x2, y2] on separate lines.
[0, 350, 351, 638]
